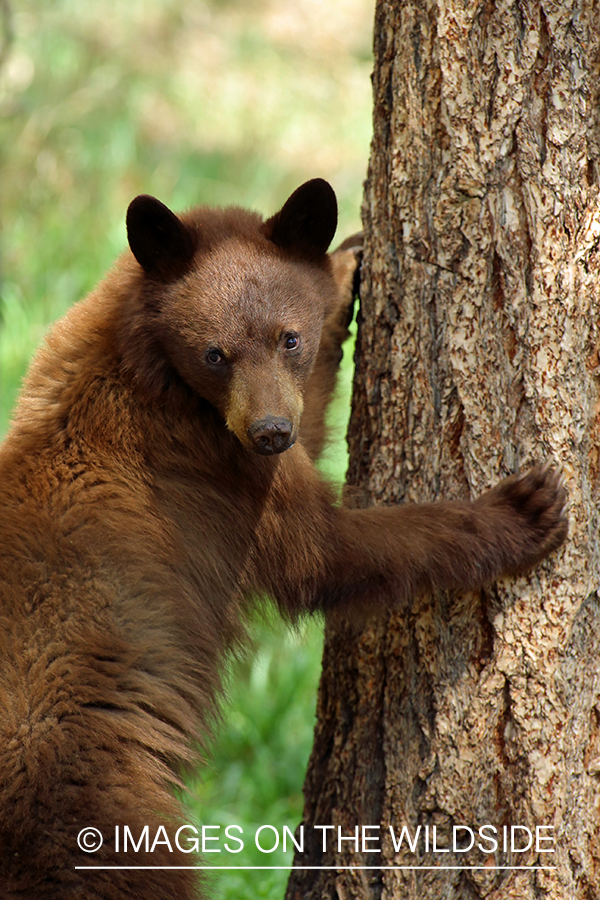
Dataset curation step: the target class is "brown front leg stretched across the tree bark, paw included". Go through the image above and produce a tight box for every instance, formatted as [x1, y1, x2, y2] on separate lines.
[258, 467, 568, 613]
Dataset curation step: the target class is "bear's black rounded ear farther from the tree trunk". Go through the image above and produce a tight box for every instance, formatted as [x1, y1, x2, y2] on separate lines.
[127, 194, 196, 281]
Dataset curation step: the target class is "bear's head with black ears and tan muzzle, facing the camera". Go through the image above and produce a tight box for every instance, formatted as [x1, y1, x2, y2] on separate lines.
[127, 178, 338, 455]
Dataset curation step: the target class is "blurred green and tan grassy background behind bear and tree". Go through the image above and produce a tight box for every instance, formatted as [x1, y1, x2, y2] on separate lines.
[0, 0, 374, 900]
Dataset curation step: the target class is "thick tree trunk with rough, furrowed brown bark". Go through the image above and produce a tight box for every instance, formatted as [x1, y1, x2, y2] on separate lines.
[288, 0, 600, 900]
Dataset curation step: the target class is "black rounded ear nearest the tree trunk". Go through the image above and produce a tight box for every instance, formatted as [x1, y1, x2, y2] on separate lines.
[262, 178, 337, 259]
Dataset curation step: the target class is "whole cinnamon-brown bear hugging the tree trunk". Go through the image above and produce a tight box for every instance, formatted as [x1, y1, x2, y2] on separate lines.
[0, 179, 567, 900]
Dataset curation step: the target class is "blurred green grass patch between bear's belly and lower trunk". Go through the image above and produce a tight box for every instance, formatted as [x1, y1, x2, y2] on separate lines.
[188, 621, 322, 900]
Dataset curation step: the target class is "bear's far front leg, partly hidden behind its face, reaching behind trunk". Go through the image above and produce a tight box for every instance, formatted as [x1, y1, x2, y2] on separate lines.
[300, 234, 362, 460]
